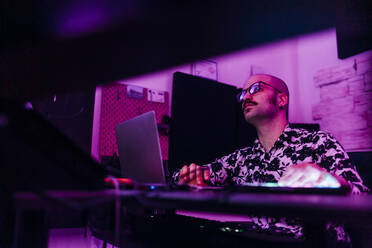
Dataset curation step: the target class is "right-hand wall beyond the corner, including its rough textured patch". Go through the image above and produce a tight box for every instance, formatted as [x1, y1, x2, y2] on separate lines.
[298, 29, 372, 152]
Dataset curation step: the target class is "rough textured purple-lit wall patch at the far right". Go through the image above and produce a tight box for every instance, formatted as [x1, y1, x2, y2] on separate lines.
[313, 54, 372, 151]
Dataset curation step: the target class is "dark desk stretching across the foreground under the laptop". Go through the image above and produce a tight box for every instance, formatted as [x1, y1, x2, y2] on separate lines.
[14, 190, 372, 247]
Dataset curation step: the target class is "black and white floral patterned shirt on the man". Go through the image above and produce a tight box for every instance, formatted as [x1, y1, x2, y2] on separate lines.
[173, 126, 368, 245]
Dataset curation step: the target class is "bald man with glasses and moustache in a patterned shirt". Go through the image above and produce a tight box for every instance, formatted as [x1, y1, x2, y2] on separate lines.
[173, 74, 368, 246]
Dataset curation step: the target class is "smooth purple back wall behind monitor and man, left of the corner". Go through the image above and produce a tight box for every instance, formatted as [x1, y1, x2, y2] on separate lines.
[91, 39, 301, 160]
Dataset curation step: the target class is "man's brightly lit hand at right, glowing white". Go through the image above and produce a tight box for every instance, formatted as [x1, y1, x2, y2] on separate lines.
[278, 162, 349, 188]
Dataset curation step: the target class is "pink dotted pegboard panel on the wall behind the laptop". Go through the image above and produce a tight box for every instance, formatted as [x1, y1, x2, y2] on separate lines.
[99, 84, 169, 160]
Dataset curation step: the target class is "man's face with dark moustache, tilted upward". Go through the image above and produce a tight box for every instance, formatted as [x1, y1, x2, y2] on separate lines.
[242, 75, 279, 124]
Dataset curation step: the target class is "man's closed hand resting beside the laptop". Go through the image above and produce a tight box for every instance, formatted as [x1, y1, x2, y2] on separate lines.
[178, 164, 210, 186]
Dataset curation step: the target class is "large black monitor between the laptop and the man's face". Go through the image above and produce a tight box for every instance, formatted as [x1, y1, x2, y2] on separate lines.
[168, 72, 256, 174]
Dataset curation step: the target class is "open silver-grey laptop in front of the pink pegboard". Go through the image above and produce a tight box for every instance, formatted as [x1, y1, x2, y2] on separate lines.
[115, 111, 166, 184]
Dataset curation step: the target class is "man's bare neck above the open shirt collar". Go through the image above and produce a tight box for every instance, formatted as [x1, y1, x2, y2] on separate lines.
[255, 118, 288, 151]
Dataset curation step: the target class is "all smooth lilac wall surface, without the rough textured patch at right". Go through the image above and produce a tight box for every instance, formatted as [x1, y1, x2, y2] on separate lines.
[92, 29, 368, 159]
